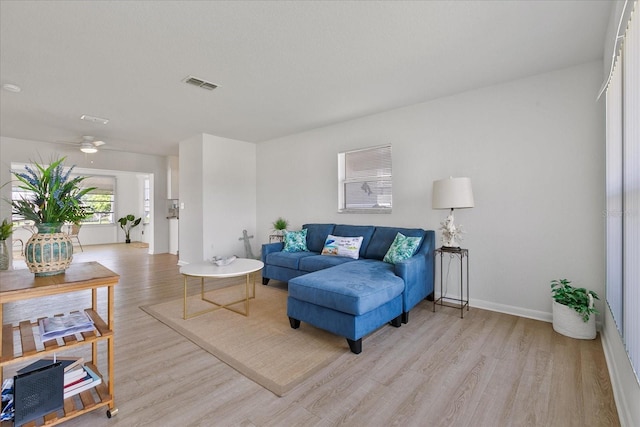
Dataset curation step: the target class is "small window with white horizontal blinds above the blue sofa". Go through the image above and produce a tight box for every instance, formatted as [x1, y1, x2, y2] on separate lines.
[338, 145, 393, 213]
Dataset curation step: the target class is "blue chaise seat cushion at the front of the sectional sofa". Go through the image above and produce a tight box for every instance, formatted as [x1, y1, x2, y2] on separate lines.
[289, 257, 404, 316]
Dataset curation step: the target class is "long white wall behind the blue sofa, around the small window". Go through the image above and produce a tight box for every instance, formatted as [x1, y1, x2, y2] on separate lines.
[257, 61, 604, 320]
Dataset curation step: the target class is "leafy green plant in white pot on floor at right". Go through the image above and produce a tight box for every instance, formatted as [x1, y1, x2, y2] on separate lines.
[551, 279, 600, 339]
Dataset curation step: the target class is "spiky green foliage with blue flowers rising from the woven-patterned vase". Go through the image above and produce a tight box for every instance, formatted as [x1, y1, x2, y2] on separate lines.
[11, 157, 95, 226]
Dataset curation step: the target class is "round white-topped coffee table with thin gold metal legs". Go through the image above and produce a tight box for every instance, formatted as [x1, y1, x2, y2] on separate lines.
[180, 258, 264, 319]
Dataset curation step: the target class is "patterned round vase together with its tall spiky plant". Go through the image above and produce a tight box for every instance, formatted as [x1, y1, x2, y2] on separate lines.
[11, 157, 95, 276]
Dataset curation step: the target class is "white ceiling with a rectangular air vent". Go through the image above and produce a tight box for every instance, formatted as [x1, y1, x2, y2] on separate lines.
[0, 0, 612, 155]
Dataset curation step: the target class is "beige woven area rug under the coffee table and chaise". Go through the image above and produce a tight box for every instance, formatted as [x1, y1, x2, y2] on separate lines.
[140, 282, 349, 396]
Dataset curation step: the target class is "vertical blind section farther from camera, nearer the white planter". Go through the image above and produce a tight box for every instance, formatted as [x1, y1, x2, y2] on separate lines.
[605, 61, 623, 334]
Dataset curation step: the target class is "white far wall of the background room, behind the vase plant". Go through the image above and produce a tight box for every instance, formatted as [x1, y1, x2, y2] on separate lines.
[0, 137, 169, 253]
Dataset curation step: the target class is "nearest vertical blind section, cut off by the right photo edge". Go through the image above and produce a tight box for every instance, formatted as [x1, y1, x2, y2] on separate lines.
[622, 4, 640, 380]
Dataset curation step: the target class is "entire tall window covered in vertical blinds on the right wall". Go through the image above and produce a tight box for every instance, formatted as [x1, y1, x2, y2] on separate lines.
[606, 3, 640, 382]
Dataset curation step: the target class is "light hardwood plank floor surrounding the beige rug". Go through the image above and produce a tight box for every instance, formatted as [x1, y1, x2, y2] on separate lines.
[5, 244, 619, 427]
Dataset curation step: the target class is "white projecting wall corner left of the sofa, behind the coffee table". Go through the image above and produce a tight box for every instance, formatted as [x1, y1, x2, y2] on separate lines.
[179, 134, 259, 263]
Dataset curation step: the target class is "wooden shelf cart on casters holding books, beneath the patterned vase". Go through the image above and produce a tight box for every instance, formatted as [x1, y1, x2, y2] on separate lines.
[0, 262, 120, 427]
